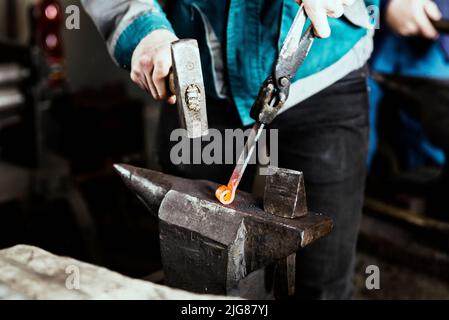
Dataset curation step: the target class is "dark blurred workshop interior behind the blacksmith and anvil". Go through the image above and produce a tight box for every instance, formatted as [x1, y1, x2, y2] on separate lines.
[0, 0, 449, 299]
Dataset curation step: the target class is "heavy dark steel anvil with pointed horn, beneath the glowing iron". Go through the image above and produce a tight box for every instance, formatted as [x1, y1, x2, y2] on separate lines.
[115, 165, 332, 294]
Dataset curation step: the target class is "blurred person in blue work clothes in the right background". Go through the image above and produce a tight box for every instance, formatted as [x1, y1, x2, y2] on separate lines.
[368, 0, 449, 220]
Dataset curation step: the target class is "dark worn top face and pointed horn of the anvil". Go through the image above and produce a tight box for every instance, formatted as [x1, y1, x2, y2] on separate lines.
[114, 164, 332, 250]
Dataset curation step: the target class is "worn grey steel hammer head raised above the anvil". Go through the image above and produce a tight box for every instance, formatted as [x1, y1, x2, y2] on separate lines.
[171, 39, 208, 138]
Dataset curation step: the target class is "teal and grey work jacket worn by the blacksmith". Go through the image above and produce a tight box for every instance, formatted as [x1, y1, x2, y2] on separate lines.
[83, 0, 378, 125]
